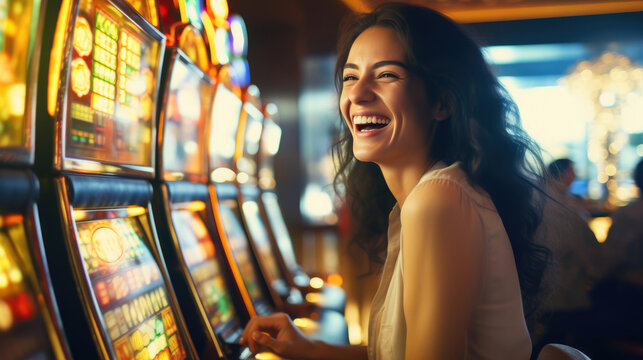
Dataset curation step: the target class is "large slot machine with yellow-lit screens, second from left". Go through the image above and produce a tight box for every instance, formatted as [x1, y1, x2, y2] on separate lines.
[36, 0, 198, 359]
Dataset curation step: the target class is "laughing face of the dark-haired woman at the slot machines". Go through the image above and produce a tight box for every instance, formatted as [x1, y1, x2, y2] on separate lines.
[340, 26, 433, 166]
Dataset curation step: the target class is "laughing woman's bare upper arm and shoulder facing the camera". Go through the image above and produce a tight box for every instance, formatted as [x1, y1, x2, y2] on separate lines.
[401, 180, 484, 359]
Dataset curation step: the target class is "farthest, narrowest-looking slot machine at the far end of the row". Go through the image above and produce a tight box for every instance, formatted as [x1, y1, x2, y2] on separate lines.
[256, 103, 346, 313]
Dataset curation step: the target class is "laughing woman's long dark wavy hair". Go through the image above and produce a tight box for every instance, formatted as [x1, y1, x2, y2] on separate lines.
[333, 3, 550, 316]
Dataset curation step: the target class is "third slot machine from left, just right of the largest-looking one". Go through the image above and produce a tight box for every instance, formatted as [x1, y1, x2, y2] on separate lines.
[155, 38, 251, 359]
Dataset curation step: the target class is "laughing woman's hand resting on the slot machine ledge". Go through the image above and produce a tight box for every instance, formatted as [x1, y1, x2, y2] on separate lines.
[241, 313, 317, 359]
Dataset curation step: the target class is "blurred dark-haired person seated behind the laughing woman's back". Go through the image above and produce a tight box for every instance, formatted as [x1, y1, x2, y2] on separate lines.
[533, 159, 604, 349]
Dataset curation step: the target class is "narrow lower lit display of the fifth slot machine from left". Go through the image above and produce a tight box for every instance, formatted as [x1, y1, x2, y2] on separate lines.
[241, 201, 283, 281]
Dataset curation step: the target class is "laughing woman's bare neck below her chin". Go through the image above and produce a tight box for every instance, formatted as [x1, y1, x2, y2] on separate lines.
[378, 160, 436, 207]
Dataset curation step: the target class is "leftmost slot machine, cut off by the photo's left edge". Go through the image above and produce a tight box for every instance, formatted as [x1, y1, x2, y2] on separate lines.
[0, 0, 70, 360]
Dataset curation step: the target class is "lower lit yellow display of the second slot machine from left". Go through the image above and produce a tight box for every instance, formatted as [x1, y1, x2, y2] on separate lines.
[76, 217, 186, 360]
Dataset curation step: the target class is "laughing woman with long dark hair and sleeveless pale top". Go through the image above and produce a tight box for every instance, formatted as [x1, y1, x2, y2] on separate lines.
[243, 4, 548, 359]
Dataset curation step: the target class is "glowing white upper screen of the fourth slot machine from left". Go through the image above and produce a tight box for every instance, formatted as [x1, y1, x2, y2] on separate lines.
[209, 84, 242, 170]
